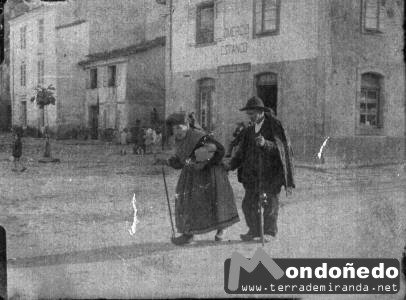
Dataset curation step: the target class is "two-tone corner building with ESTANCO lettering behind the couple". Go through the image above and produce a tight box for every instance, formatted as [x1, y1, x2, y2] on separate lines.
[166, 0, 405, 164]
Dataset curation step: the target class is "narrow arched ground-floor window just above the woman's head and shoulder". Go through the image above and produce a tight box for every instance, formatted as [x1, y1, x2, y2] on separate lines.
[198, 78, 214, 130]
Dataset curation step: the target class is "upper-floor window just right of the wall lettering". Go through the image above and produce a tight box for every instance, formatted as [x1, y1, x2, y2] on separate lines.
[254, 0, 280, 36]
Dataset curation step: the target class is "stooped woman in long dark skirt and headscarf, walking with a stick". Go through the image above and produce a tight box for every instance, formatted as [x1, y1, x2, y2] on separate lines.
[160, 113, 240, 245]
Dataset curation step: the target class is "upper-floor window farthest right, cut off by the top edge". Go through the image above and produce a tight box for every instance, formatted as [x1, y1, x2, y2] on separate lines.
[362, 0, 385, 32]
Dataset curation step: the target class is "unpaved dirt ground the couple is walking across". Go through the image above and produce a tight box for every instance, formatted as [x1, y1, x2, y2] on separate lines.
[0, 137, 406, 299]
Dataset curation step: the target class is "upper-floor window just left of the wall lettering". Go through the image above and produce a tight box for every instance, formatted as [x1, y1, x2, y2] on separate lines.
[196, 3, 214, 44]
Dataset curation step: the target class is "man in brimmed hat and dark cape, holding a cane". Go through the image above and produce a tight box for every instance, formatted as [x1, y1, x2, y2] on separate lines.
[226, 97, 295, 241]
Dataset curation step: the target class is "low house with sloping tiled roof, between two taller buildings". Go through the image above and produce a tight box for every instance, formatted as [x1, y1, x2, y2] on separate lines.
[79, 37, 165, 136]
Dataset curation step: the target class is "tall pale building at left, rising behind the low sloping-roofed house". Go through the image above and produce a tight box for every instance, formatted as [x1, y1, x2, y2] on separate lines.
[10, 0, 164, 137]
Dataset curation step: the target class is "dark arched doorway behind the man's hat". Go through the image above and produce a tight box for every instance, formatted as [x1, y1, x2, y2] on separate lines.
[256, 73, 278, 115]
